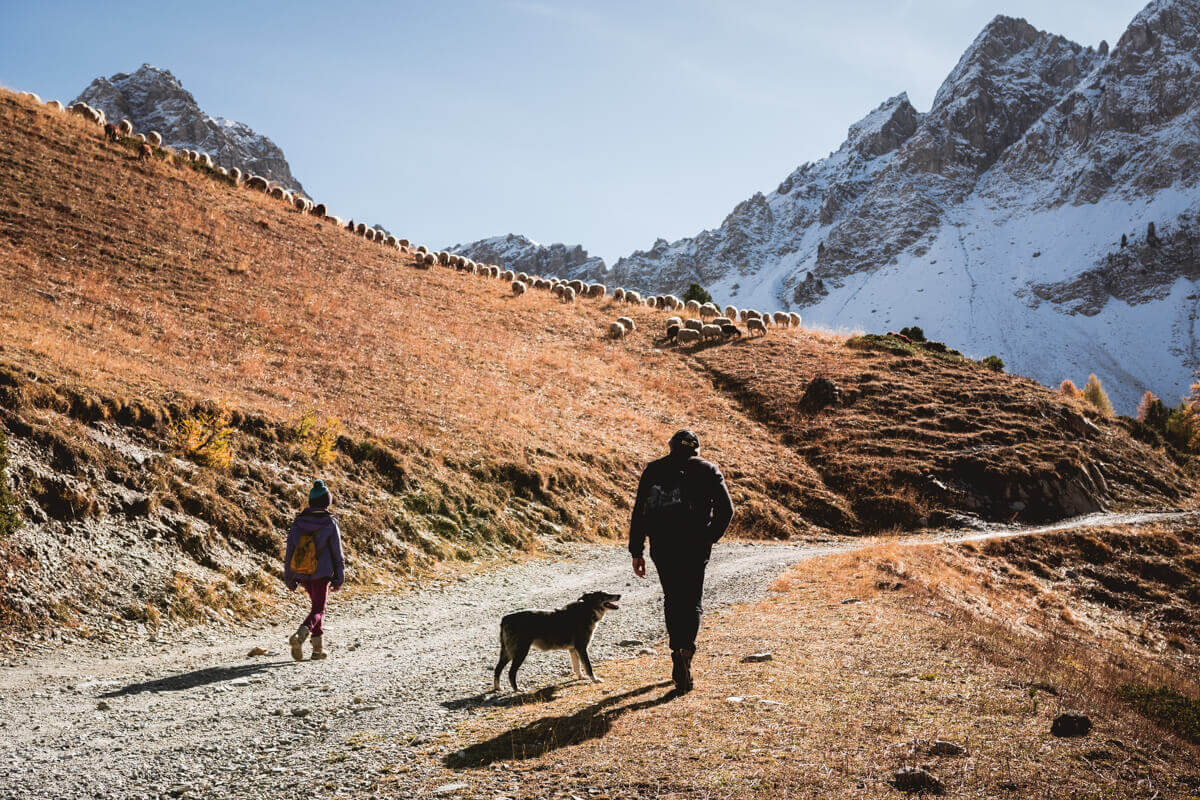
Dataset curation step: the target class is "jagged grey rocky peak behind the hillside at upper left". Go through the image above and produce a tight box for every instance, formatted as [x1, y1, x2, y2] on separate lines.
[72, 64, 304, 193]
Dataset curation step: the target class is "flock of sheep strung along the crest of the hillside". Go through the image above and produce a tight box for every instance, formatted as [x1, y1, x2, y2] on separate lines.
[11, 92, 800, 344]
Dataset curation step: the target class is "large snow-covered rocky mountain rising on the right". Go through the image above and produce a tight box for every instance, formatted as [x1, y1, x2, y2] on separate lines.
[528, 0, 1200, 419]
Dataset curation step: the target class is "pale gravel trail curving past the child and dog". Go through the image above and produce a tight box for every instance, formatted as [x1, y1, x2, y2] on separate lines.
[0, 512, 1188, 800]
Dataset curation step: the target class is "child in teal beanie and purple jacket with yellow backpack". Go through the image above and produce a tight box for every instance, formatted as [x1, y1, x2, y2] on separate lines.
[283, 480, 346, 661]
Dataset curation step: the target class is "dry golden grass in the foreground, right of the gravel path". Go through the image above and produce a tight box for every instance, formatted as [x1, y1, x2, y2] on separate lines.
[410, 534, 1200, 799]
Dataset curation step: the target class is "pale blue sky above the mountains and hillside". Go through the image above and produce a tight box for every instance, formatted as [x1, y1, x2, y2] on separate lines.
[0, 0, 1144, 263]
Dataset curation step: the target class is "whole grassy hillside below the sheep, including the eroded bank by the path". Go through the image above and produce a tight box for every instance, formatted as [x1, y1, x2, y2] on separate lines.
[0, 87, 1192, 630]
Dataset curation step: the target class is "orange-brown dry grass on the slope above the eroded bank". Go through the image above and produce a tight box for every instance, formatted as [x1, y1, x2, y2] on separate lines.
[0, 87, 1186, 546]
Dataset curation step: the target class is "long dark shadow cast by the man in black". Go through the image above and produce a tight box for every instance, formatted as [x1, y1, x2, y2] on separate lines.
[442, 681, 679, 769]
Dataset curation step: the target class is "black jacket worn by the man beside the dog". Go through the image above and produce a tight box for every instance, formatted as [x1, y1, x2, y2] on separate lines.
[629, 453, 733, 558]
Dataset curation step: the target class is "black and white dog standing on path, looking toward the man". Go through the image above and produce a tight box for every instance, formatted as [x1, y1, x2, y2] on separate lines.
[492, 591, 620, 692]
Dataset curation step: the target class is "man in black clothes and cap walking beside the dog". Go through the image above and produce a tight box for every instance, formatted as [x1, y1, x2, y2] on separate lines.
[629, 431, 733, 692]
